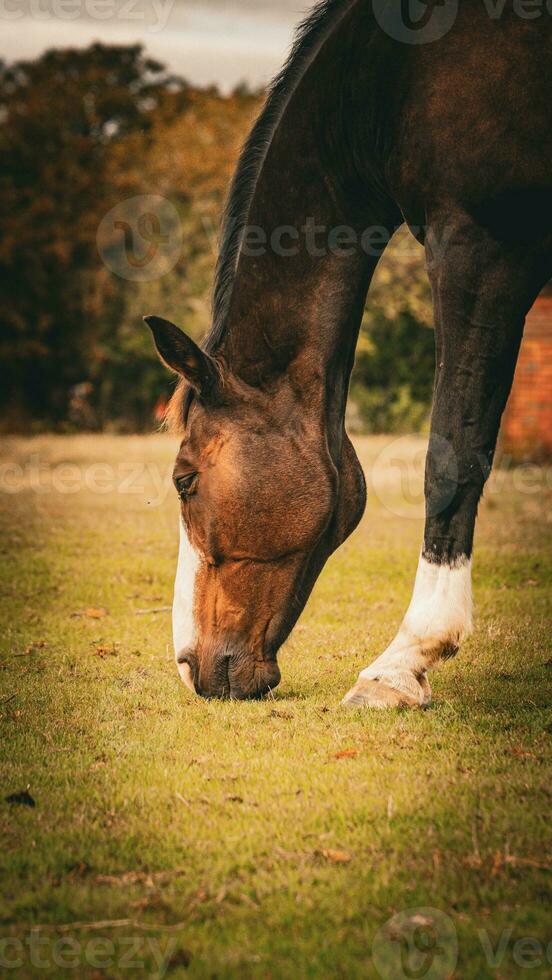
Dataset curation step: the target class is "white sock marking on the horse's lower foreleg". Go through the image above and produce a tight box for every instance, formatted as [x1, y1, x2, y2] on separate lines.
[345, 557, 472, 705]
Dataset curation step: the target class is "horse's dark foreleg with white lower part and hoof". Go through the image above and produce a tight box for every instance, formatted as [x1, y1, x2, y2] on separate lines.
[343, 215, 550, 708]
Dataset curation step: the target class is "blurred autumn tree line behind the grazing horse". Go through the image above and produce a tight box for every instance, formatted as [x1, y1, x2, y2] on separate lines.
[0, 44, 434, 431]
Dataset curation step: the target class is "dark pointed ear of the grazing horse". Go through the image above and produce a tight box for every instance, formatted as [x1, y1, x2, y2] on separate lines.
[144, 316, 219, 396]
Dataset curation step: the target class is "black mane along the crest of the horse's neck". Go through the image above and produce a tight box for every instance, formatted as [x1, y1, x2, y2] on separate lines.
[204, 0, 355, 351]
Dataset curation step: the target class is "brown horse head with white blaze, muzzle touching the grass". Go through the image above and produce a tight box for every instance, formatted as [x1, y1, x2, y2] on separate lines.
[146, 317, 365, 699]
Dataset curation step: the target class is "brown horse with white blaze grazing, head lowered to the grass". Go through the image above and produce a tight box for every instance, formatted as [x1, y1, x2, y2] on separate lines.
[146, 0, 552, 707]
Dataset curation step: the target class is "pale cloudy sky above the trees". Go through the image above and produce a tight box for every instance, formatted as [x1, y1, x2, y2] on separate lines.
[0, 0, 320, 91]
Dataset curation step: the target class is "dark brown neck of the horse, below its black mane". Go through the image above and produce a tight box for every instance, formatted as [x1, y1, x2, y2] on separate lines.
[210, 3, 395, 432]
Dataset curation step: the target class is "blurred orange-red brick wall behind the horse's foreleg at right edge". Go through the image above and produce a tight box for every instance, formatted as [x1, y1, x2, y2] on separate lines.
[501, 289, 552, 459]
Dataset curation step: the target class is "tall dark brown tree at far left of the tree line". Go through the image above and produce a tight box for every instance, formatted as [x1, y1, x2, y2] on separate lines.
[0, 44, 185, 424]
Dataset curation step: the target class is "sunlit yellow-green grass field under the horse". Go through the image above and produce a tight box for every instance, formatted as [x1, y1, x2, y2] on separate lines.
[0, 436, 552, 980]
